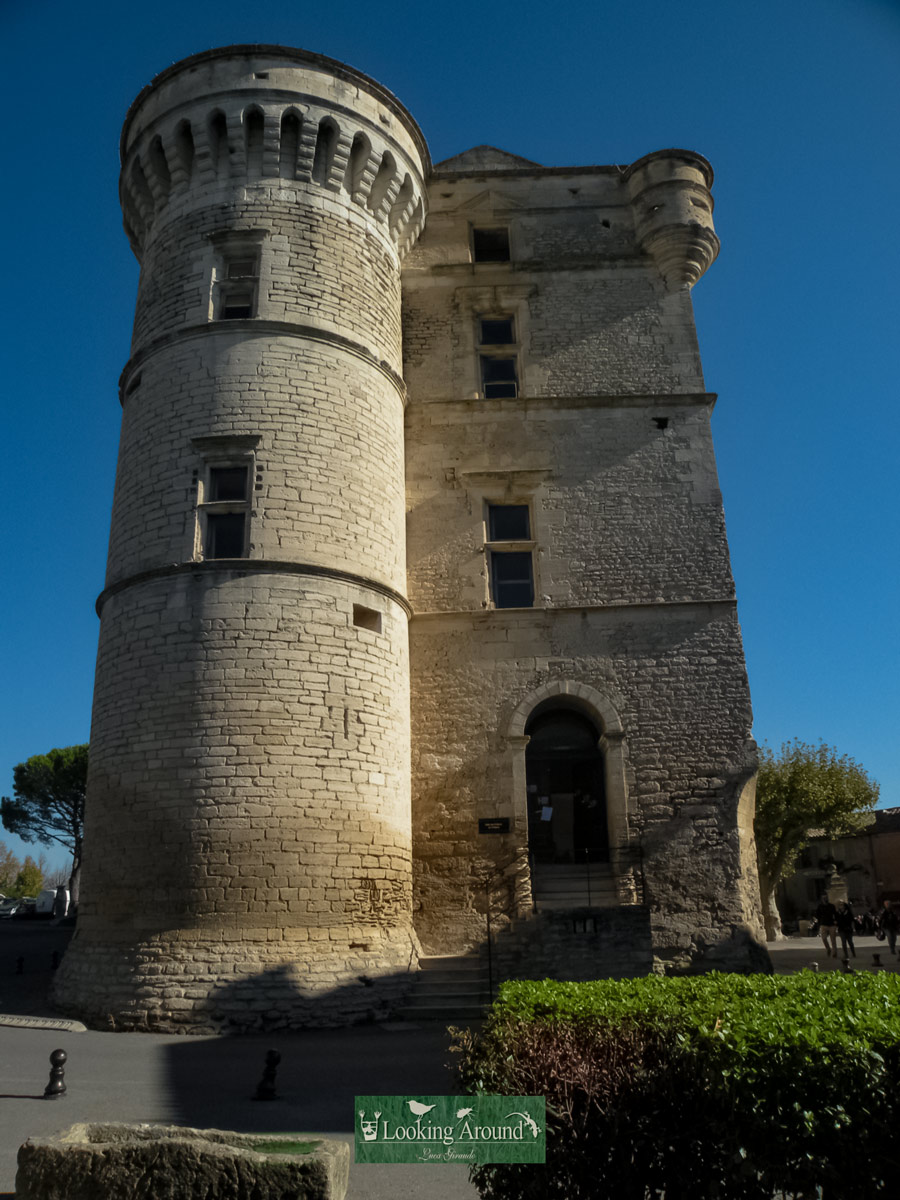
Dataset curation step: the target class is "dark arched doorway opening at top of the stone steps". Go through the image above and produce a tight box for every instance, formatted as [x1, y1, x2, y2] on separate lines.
[526, 708, 610, 863]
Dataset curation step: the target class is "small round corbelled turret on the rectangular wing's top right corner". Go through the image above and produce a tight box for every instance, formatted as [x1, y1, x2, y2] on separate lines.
[625, 150, 719, 290]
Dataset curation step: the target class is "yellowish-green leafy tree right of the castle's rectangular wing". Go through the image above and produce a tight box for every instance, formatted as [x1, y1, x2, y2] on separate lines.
[754, 740, 878, 941]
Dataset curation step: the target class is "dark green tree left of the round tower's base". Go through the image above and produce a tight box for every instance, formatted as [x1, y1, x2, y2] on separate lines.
[0, 745, 88, 905]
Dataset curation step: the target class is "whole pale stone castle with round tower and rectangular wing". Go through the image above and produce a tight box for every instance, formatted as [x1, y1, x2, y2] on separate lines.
[56, 46, 761, 1028]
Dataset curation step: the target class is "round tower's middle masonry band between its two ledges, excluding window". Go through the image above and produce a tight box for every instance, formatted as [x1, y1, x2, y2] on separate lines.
[107, 333, 406, 592]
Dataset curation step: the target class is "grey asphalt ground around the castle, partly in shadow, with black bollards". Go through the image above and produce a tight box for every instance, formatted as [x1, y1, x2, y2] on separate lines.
[0, 922, 900, 1200]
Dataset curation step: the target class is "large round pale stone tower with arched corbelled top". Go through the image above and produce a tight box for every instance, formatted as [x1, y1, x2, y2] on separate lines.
[56, 46, 430, 1028]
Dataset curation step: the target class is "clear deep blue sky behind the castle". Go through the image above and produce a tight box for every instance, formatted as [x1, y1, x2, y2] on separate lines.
[0, 0, 900, 859]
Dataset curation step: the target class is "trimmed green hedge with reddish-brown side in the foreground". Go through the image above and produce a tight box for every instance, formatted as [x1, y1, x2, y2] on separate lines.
[456, 972, 900, 1200]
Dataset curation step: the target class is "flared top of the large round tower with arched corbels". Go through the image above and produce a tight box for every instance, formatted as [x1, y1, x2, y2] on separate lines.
[120, 46, 431, 257]
